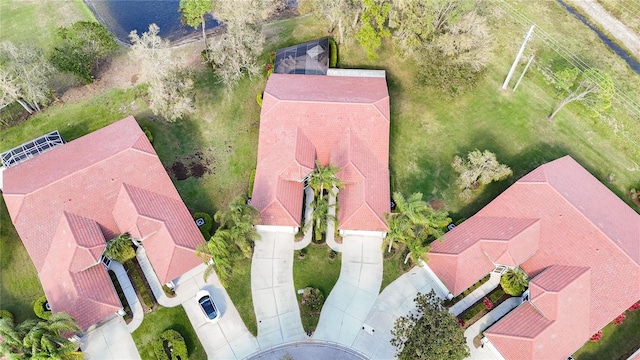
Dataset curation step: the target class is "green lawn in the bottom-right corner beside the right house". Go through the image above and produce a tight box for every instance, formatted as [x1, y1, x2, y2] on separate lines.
[573, 310, 640, 360]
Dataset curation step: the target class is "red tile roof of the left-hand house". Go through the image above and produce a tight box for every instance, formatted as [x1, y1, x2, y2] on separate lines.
[3, 117, 204, 328]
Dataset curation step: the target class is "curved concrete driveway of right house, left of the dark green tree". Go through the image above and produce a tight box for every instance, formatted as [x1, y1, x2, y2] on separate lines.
[352, 267, 446, 360]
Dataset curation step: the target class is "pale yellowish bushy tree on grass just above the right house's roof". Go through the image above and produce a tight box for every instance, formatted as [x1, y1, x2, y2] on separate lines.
[451, 149, 512, 199]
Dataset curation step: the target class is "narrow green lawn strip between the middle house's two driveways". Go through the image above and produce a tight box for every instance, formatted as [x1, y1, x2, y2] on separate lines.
[293, 243, 342, 329]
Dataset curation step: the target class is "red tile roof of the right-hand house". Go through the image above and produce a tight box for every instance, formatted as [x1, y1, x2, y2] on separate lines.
[429, 156, 640, 358]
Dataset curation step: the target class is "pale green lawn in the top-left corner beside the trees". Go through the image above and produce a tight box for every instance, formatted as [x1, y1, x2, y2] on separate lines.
[0, 0, 95, 50]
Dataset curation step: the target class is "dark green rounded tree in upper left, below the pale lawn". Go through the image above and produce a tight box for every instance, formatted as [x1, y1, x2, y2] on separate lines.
[50, 21, 118, 83]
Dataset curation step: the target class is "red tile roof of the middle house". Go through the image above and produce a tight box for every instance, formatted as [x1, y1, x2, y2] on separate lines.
[252, 74, 390, 231]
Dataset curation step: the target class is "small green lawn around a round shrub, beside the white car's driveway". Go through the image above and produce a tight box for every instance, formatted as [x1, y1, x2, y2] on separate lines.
[132, 306, 207, 360]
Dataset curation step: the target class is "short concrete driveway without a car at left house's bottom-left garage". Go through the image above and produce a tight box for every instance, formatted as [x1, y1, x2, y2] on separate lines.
[80, 316, 140, 360]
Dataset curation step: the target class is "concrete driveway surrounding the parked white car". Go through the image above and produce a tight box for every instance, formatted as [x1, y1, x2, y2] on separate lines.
[176, 266, 259, 359]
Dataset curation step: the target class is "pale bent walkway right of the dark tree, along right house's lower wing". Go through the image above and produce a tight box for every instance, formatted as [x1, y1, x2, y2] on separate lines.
[464, 297, 522, 360]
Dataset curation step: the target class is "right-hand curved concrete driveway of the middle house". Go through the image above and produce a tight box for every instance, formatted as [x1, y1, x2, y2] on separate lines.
[313, 236, 382, 347]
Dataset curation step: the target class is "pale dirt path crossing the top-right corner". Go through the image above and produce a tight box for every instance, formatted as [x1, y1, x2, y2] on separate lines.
[571, 0, 640, 59]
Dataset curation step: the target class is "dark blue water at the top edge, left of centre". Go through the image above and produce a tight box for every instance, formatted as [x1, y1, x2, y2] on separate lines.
[84, 0, 219, 44]
